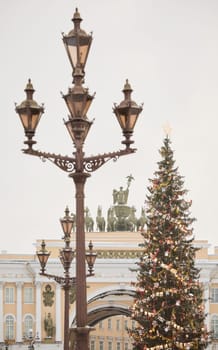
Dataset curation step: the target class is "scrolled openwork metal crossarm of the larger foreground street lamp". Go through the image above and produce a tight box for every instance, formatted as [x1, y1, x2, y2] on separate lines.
[23, 147, 136, 173]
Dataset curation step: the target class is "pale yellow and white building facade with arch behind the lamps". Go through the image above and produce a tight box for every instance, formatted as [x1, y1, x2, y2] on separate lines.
[0, 231, 218, 350]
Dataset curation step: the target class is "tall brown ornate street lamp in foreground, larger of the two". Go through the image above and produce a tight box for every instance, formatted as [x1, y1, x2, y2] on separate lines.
[15, 9, 142, 350]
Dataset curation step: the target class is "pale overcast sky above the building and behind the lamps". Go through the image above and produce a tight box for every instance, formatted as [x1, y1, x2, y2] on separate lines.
[0, 0, 218, 253]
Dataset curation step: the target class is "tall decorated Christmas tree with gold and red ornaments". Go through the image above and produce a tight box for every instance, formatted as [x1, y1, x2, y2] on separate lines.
[129, 136, 208, 350]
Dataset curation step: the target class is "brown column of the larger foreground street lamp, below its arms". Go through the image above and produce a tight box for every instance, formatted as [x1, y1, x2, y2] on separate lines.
[70, 172, 90, 350]
